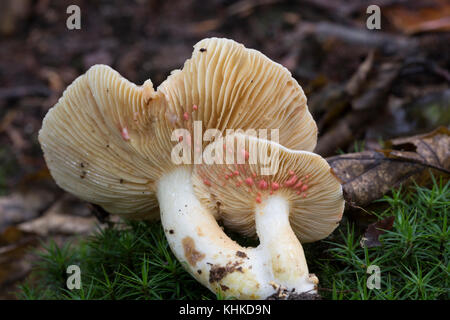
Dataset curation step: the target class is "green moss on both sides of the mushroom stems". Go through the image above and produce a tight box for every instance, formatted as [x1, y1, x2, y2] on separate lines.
[18, 181, 450, 299]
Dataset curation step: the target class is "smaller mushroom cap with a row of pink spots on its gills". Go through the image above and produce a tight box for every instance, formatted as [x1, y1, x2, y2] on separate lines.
[192, 134, 345, 242]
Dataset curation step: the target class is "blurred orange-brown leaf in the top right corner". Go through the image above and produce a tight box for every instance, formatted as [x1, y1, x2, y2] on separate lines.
[383, 0, 450, 34]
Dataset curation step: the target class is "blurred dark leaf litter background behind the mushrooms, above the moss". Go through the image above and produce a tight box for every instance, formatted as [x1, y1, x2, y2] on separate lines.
[0, 0, 450, 298]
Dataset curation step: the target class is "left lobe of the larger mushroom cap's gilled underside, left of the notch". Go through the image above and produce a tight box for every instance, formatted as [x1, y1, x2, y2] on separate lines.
[39, 65, 176, 218]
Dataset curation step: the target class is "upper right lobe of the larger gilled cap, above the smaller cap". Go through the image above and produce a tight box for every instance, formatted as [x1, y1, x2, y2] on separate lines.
[158, 38, 317, 151]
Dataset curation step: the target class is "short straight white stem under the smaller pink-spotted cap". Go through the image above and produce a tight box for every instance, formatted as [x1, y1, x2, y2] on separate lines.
[255, 195, 318, 293]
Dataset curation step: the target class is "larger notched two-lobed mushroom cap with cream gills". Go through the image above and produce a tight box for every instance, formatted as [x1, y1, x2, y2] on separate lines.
[39, 38, 317, 218]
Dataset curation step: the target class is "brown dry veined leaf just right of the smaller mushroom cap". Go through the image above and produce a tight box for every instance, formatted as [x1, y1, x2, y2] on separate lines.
[327, 127, 450, 207]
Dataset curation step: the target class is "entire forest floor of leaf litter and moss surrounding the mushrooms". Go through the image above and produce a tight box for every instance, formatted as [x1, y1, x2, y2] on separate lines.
[0, 0, 450, 299]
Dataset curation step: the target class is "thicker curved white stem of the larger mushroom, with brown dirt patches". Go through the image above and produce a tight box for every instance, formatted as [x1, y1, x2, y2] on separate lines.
[157, 167, 264, 299]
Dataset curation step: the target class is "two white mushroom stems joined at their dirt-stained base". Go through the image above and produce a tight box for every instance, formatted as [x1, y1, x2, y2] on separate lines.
[157, 167, 315, 299]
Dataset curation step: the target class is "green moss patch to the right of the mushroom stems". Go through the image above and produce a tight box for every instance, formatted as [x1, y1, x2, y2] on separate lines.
[305, 181, 450, 300]
